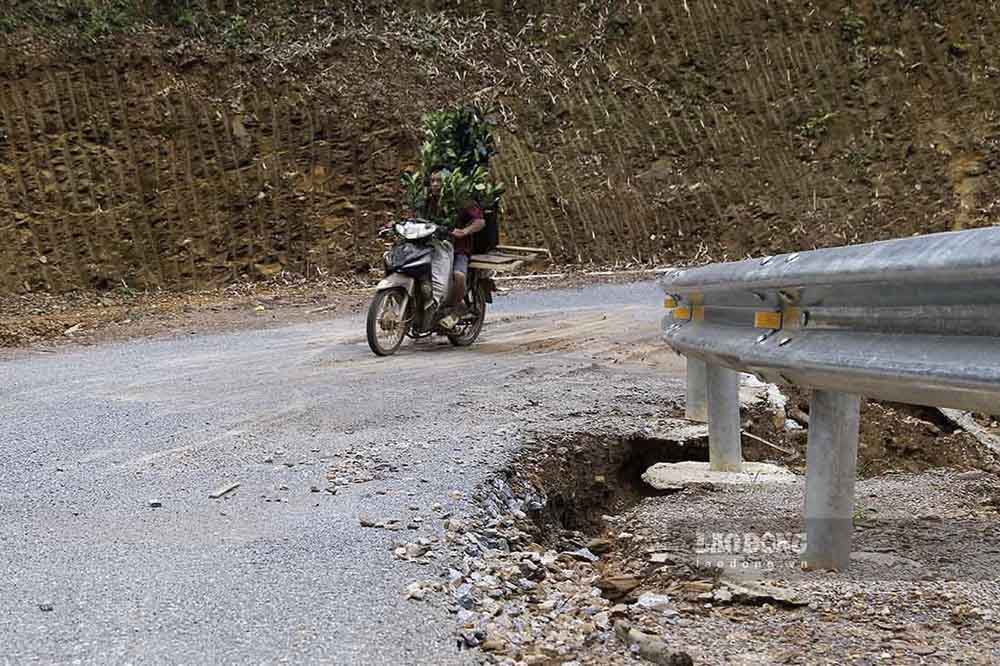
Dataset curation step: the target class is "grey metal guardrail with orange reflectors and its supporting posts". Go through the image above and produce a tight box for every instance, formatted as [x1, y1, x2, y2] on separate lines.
[660, 228, 1000, 568]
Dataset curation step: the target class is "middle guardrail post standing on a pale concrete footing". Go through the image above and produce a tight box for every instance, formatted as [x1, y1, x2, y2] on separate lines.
[705, 365, 743, 472]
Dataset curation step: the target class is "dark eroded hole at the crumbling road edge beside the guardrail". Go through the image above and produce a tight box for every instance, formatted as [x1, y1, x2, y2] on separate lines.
[486, 433, 708, 547]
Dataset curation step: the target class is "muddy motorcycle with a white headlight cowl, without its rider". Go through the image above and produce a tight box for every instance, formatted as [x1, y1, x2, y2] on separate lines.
[366, 218, 495, 356]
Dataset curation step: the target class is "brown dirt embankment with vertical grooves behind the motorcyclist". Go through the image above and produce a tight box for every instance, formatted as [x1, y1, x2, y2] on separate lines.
[0, 0, 1000, 292]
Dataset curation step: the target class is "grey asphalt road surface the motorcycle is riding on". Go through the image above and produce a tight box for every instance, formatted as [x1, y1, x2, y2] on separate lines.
[0, 283, 680, 664]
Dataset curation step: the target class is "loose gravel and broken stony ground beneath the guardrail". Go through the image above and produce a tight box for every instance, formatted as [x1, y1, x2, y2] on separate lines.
[450, 470, 1000, 664]
